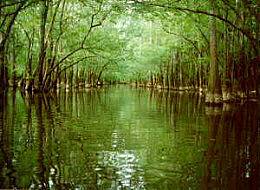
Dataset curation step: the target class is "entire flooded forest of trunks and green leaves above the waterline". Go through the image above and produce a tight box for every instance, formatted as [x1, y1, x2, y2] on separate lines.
[0, 0, 260, 104]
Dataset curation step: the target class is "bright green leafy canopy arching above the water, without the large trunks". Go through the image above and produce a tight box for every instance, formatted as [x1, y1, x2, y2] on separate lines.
[0, 0, 259, 90]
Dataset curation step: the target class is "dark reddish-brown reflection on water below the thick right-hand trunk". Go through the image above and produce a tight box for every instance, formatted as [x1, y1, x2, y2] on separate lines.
[203, 103, 260, 189]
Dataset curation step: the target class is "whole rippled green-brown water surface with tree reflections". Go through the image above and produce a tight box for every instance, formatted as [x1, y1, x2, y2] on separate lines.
[0, 86, 260, 190]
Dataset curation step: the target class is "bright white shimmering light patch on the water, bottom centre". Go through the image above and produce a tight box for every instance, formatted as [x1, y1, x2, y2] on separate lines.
[95, 150, 144, 189]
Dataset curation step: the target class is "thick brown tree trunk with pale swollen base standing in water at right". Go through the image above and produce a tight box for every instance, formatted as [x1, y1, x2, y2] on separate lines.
[206, 0, 222, 104]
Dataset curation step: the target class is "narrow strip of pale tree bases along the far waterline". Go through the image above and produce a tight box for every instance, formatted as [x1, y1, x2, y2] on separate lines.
[5, 78, 259, 106]
